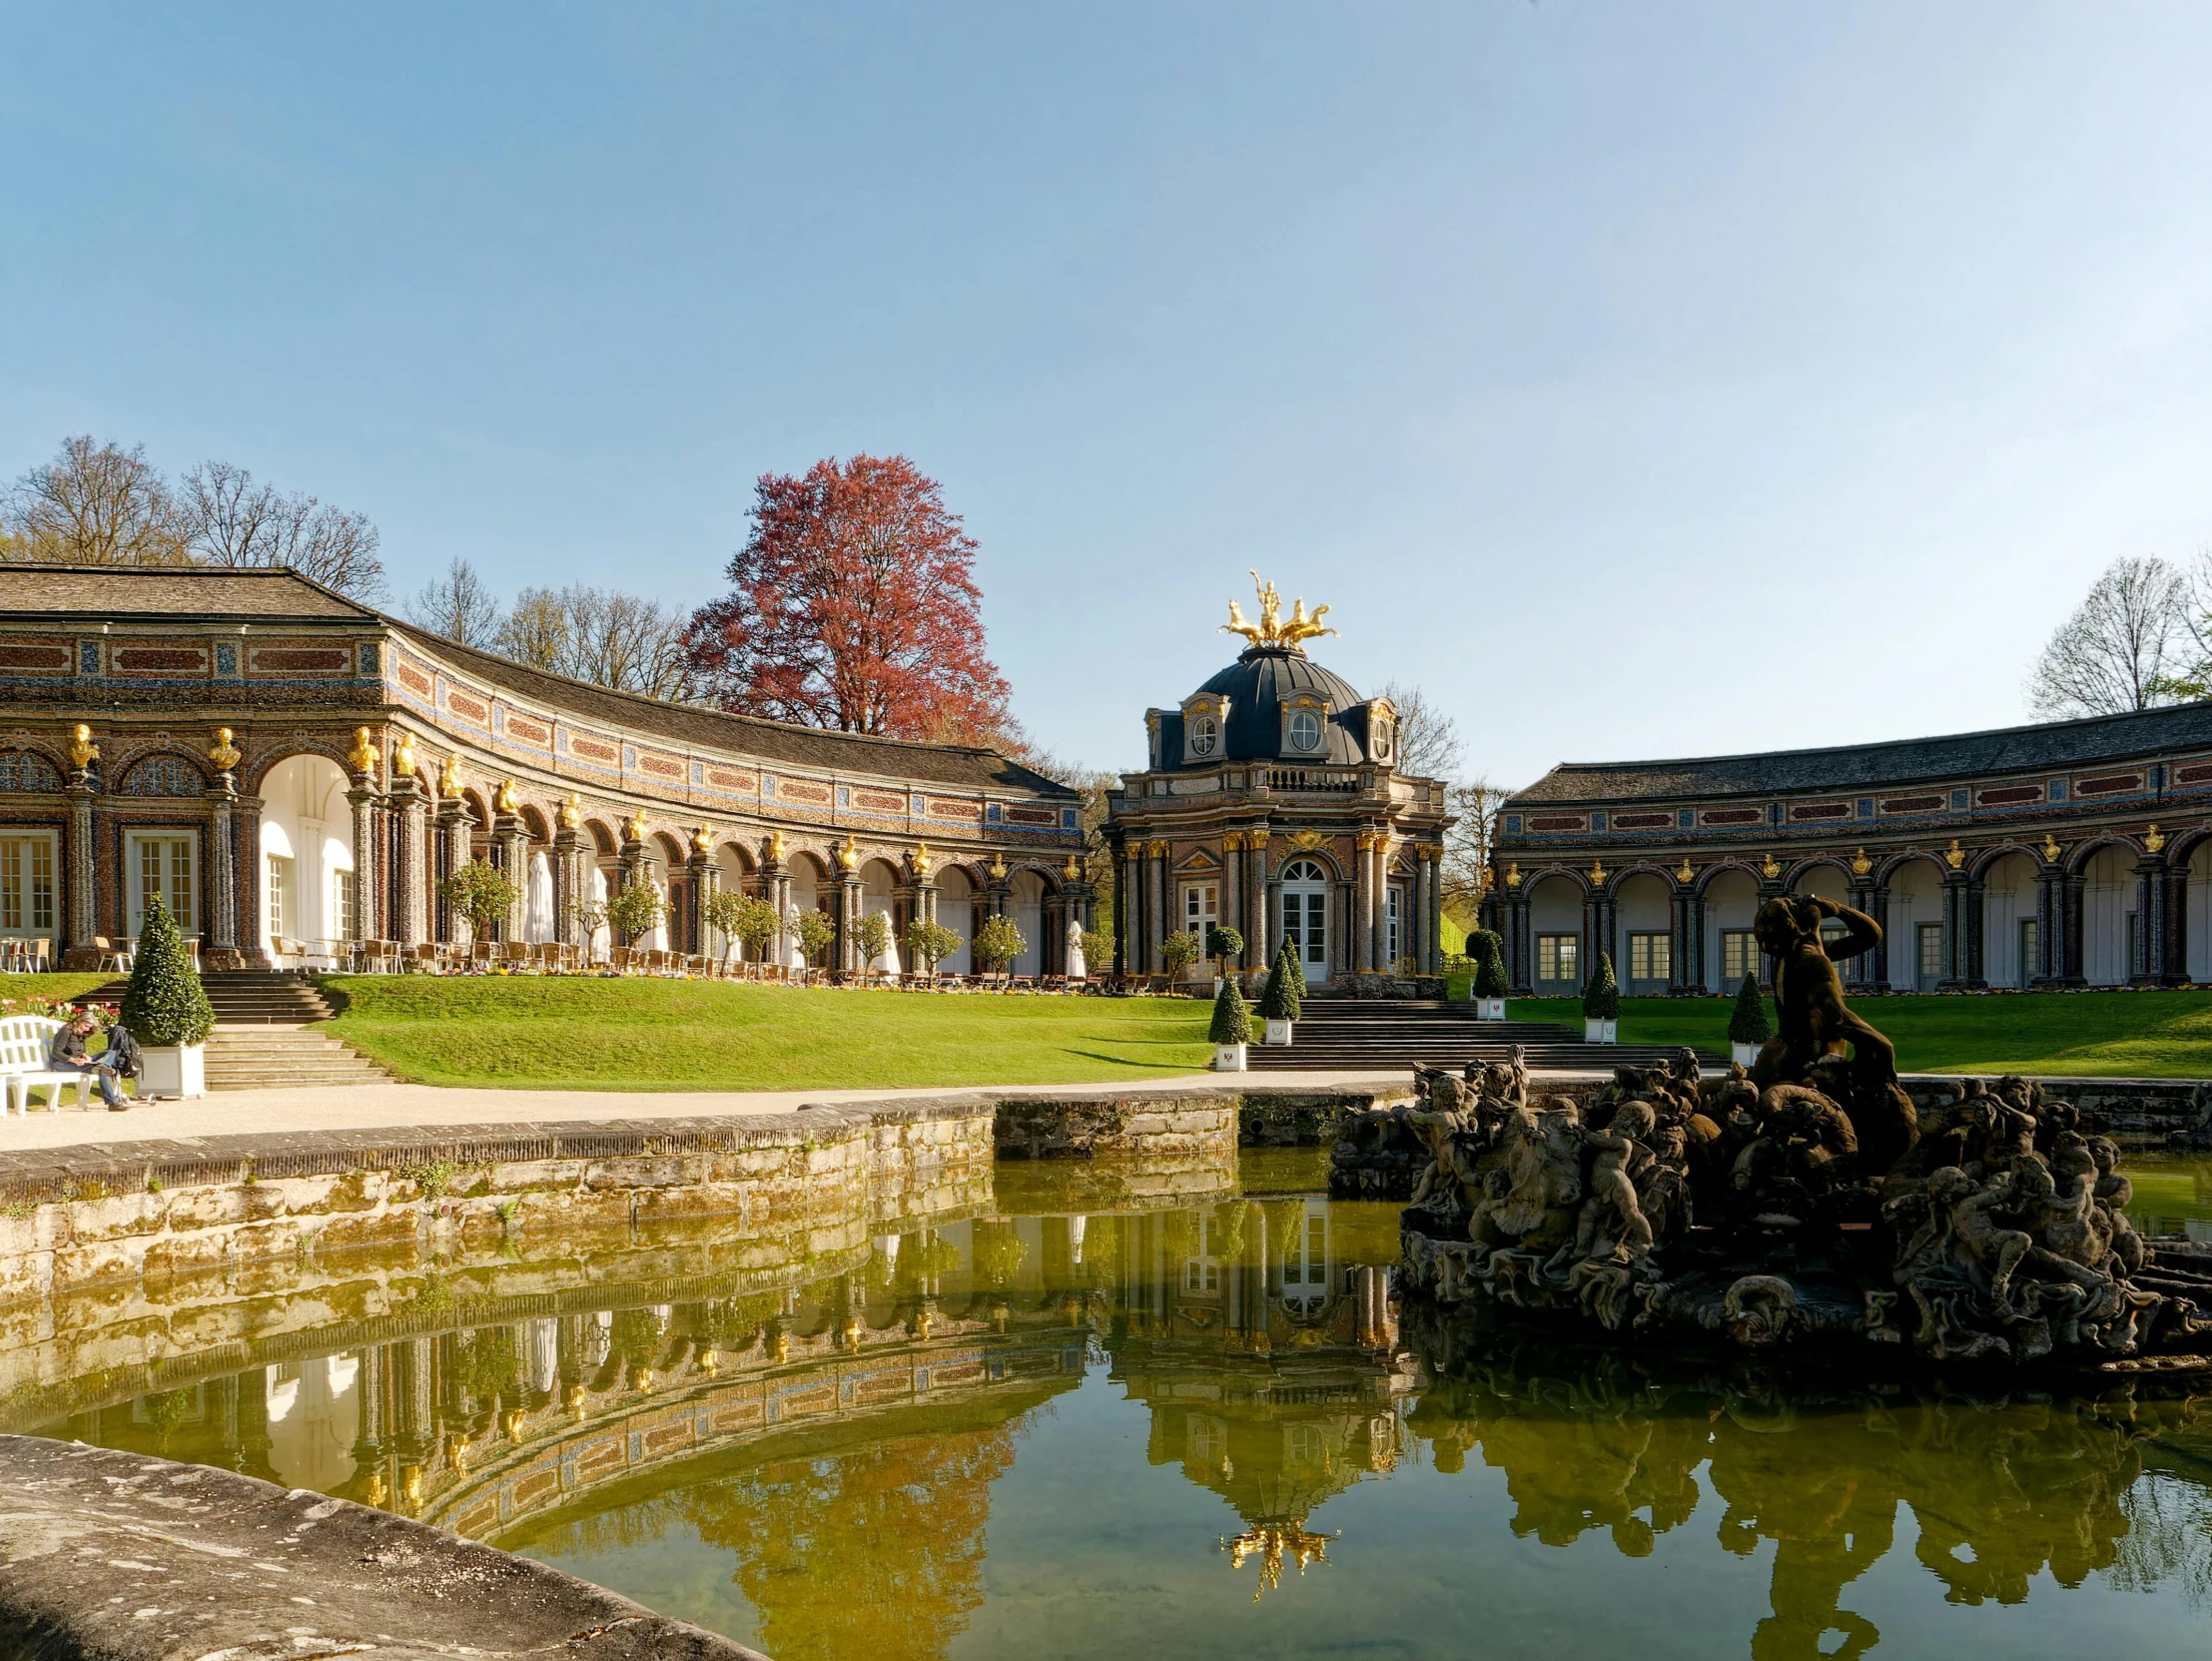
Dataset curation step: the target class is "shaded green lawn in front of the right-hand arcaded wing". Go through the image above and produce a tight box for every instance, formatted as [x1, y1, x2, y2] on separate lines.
[1506, 991, 2212, 1080]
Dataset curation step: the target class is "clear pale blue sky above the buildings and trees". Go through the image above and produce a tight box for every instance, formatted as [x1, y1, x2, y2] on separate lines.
[0, 0, 2212, 783]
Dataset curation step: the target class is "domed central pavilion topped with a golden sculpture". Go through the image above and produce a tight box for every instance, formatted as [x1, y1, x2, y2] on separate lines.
[1106, 584, 1451, 991]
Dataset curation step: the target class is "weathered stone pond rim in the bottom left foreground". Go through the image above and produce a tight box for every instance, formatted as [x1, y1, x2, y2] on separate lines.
[0, 1435, 761, 1661]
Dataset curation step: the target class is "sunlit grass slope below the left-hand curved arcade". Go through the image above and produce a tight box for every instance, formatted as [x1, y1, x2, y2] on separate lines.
[326, 976, 1212, 1091]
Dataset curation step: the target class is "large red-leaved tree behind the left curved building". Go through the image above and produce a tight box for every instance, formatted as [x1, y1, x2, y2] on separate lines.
[688, 455, 1009, 743]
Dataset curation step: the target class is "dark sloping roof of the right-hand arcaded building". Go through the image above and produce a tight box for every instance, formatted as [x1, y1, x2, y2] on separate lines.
[1509, 703, 2212, 807]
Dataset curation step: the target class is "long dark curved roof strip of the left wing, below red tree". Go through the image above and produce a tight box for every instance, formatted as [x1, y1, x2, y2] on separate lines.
[400, 623, 1078, 801]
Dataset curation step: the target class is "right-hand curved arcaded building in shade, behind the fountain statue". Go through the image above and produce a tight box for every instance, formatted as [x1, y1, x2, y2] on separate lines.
[1484, 703, 2212, 995]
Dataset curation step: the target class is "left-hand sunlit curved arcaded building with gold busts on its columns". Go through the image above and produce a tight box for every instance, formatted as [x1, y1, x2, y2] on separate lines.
[0, 566, 1091, 973]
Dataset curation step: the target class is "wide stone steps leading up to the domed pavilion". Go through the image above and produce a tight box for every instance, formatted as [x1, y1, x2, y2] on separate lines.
[1245, 993, 1728, 1073]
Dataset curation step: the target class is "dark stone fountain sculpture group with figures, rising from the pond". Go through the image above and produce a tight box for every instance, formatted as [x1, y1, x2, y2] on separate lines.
[1380, 898, 2212, 1369]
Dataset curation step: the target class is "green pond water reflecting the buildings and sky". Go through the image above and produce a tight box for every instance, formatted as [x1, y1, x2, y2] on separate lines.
[21, 1155, 2212, 1661]
